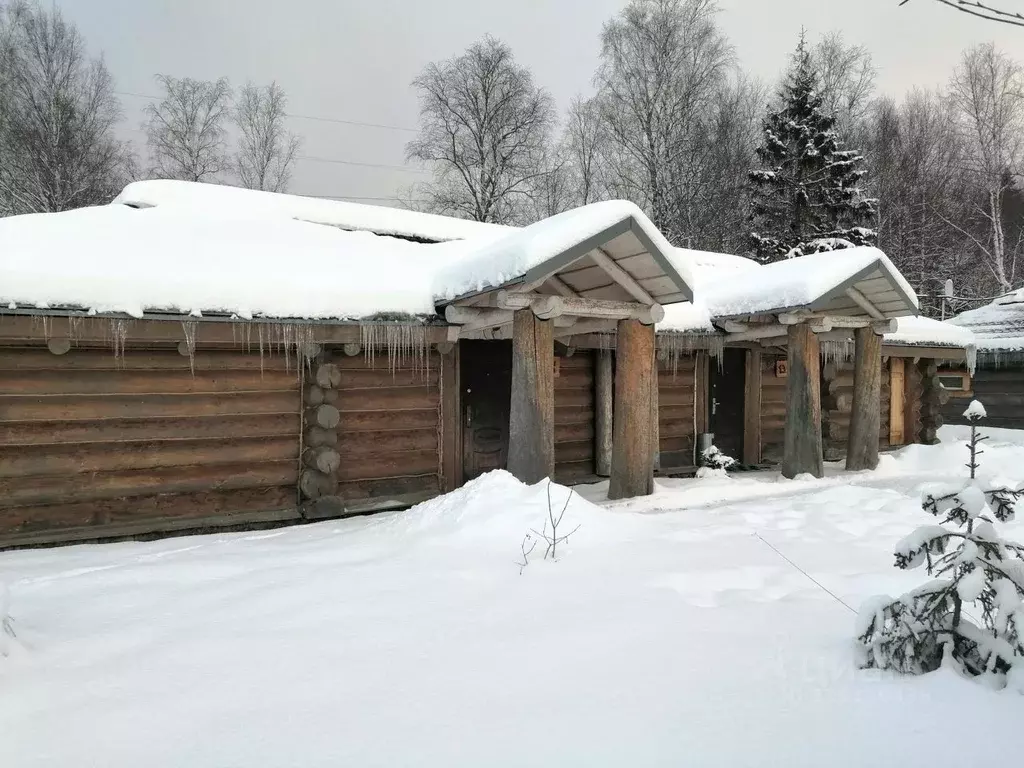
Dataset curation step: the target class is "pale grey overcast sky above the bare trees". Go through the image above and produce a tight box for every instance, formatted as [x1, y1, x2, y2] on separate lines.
[58, 0, 1024, 205]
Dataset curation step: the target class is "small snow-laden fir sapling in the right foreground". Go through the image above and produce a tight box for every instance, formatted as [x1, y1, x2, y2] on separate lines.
[857, 400, 1024, 692]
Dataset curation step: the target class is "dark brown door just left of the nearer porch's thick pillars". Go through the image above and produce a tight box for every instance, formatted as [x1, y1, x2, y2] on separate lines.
[459, 341, 512, 480]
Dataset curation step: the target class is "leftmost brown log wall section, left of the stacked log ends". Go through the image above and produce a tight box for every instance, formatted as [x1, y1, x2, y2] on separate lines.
[0, 343, 301, 544]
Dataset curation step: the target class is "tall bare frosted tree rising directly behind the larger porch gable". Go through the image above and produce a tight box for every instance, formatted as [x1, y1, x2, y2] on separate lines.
[595, 0, 733, 242]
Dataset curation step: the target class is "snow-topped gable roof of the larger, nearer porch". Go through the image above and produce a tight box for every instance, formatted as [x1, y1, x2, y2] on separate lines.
[434, 200, 693, 304]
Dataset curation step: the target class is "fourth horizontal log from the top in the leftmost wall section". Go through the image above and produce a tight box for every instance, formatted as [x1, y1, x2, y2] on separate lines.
[0, 413, 299, 445]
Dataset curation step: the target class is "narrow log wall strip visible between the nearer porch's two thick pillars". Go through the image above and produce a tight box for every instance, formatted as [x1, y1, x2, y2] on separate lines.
[555, 349, 600, 482]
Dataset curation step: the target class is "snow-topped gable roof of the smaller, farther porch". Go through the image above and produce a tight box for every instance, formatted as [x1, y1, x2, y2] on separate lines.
[701, 248, 918, 317]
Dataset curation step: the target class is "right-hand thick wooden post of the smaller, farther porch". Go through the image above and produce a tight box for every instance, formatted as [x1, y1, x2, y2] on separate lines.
[846, 327, 882, 470]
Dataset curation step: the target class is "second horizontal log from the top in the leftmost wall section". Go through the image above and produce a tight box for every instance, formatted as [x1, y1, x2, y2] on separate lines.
[0, 370, 299, 396]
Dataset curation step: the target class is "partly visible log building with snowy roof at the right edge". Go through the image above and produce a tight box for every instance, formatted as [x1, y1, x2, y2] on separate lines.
[939, 290, 1024, 429]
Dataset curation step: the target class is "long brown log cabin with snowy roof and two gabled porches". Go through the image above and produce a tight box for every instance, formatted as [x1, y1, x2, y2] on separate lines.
[0, 181, 973, 547]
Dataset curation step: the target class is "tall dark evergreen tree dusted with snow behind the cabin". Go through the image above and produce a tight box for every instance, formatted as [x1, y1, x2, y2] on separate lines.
[750, 34, 876, 262]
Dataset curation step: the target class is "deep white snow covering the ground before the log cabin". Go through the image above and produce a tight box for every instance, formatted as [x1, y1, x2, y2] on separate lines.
[0, 429, 1024, 768]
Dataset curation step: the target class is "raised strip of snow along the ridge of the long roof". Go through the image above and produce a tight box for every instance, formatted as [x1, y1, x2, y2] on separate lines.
[114, 179, 515, 243]
